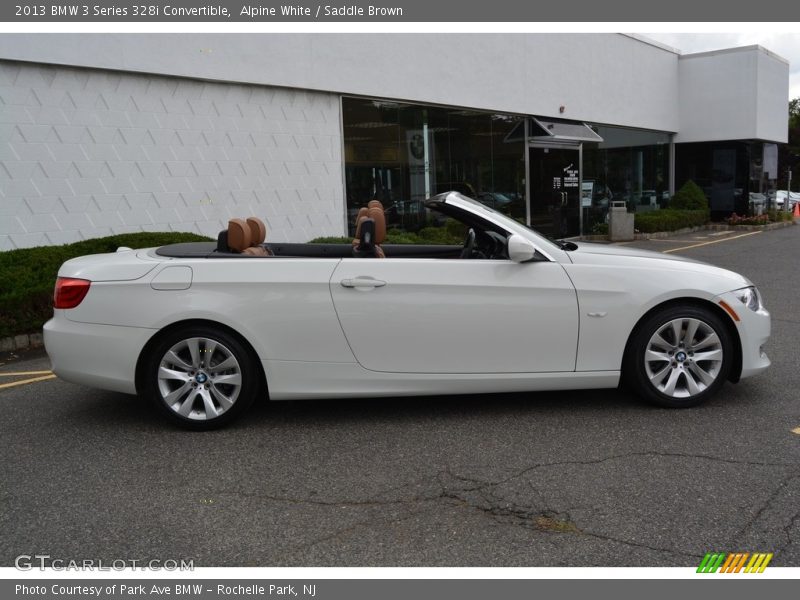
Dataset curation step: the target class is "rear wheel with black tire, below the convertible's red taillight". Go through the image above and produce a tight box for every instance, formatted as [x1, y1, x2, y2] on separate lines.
[143, 326, 263, 430]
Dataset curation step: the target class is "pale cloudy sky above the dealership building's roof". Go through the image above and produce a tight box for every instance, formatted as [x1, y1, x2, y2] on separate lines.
[642, 32, 800, 99]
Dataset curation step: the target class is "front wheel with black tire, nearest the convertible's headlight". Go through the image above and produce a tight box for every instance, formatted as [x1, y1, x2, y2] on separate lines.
[623, 305, 735, 408]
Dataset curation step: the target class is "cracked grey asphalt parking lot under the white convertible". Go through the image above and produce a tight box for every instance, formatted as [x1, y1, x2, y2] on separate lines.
[0, 227, 800, 566]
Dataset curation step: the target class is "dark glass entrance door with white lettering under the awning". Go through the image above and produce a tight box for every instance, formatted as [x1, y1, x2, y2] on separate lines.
[528, 145, 581, 239]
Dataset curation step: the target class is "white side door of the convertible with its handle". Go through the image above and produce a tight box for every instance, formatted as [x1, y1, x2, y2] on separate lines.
[330, 258, 578, 373]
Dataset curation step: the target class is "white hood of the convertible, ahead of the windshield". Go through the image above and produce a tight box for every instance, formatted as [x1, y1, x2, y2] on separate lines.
[566, 242, 752, 289]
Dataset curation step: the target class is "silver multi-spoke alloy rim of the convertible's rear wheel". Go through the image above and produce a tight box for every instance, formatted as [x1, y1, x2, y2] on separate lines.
[157, 337, 242, 421]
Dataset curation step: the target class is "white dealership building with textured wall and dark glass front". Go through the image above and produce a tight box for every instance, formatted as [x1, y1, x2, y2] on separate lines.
[0, 33, 789, 250]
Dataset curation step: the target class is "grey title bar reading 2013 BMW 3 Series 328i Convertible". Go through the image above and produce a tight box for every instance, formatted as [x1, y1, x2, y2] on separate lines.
[0, 0, 800, 23]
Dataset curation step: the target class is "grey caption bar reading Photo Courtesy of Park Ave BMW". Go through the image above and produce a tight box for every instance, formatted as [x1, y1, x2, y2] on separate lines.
[0, 575, 795, 600]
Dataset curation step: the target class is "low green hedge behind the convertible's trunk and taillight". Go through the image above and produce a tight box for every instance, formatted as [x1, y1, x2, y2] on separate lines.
[0, 232, 210, 337]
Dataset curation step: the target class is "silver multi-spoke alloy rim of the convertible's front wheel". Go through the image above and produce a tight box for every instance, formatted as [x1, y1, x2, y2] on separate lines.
[644, 317, 723, 398]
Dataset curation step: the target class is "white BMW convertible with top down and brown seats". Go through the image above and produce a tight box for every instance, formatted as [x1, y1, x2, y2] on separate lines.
[44, 192, 770, 429]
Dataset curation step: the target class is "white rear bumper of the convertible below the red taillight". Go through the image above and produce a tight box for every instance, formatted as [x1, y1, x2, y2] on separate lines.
[44, 310, 156, 394]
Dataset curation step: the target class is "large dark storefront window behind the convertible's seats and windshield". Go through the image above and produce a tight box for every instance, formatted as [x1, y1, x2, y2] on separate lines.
[342, 98, 525, 234]
